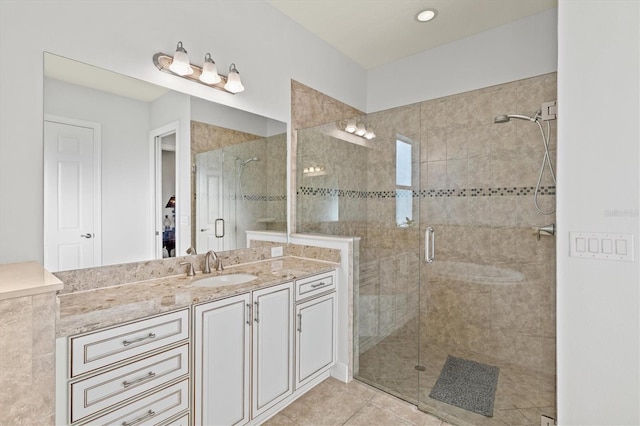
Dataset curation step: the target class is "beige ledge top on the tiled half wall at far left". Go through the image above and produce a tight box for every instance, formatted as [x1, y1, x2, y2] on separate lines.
[0, 262, 63, 300]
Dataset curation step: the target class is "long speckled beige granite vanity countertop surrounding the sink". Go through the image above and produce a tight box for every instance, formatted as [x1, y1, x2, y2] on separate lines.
[56, 257, 338, 337]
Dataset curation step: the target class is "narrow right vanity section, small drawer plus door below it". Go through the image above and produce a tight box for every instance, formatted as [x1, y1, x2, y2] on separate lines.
[295, 272, 337, 389]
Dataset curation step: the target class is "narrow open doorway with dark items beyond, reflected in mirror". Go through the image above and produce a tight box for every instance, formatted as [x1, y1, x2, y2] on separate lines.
[155, 130, 177, 258]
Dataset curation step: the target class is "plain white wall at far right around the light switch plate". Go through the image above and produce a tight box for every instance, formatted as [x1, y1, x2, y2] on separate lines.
[557, 0, 640, 425]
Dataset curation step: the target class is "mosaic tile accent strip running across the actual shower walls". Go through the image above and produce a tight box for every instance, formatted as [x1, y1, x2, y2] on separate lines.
[297, 186, 556, 198]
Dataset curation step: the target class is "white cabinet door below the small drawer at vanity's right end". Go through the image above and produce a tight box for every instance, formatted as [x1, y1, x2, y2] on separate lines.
[296, 293, 336, 387]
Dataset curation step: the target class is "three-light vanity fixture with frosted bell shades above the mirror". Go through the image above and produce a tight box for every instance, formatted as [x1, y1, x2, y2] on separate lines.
[153, 41, 244, 95]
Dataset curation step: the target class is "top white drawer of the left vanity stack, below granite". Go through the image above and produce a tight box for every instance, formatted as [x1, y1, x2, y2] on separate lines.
[70, 309, 189, 377]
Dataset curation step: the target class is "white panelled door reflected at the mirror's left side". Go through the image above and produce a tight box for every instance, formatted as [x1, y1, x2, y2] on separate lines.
[44, 116, 102, 272]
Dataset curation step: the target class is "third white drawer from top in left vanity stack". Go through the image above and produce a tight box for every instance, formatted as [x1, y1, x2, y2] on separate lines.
[76, 380, 189, 426]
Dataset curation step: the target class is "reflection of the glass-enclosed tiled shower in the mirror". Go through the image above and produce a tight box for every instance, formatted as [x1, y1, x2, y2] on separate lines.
[192, 131, 287, 253]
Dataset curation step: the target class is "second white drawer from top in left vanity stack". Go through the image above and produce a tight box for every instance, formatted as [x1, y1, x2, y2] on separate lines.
[70, 345, 189, 422]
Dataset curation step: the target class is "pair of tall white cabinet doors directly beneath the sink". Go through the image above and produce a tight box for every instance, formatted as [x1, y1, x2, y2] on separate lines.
[194, 282, 294, 425]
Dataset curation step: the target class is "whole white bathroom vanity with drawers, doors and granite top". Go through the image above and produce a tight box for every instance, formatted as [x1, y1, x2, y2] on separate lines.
[56, 257, 338, 425]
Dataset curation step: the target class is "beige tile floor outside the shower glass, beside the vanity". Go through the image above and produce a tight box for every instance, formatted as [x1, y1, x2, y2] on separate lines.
[263, 377, 450, 426]
